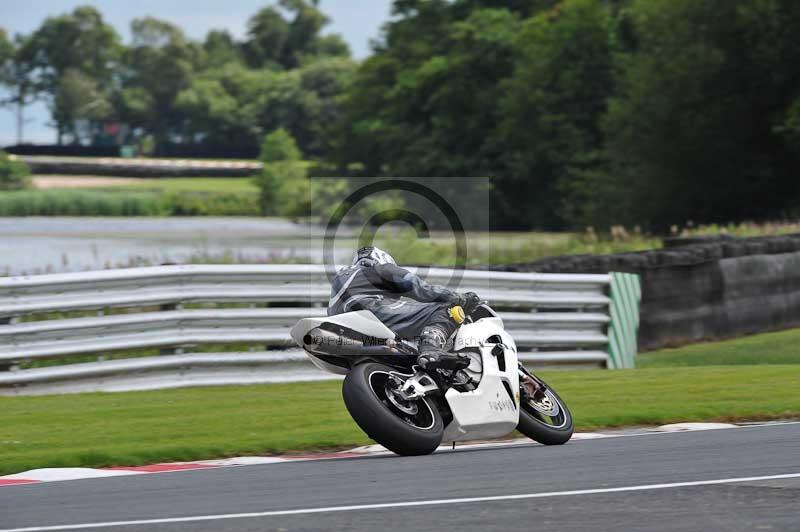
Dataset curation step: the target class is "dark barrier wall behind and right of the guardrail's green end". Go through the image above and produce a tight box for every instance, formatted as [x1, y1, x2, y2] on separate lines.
[496, 234, 800, 350]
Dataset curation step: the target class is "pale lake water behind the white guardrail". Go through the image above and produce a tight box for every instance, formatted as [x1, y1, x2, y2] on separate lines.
[0, 217, 352, 275]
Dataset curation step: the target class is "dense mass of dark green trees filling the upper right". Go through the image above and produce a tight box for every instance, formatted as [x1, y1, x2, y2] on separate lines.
[329, 0, 800, 230]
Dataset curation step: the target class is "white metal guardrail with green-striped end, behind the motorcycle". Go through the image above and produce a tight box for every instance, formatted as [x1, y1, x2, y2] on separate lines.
[0, 265, 640, 395]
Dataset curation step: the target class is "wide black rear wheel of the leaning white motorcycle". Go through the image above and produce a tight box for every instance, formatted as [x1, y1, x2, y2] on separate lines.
[342, 362, 444, 456]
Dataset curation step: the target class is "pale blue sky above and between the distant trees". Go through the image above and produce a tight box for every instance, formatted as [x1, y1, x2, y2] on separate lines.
[0, 0, 391, 146]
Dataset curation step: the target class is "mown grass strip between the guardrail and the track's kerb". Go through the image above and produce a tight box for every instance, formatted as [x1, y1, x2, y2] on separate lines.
[0, 365, 800, 474]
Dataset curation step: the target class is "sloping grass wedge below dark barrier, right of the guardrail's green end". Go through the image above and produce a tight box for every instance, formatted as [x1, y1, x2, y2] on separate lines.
[636, 329, 800, 368]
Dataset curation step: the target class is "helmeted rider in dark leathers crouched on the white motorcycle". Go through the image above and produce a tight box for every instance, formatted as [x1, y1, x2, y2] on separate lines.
[328, 246, 480, 370]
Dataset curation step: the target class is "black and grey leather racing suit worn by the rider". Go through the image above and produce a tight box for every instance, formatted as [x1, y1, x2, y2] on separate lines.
[328, 264, 462, 352]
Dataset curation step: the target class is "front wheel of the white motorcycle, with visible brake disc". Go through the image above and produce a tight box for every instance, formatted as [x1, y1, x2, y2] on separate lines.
[517, 377, 574, 445]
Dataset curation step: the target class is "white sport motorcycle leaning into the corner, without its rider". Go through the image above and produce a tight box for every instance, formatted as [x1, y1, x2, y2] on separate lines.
[291, 303, 573, 455]
